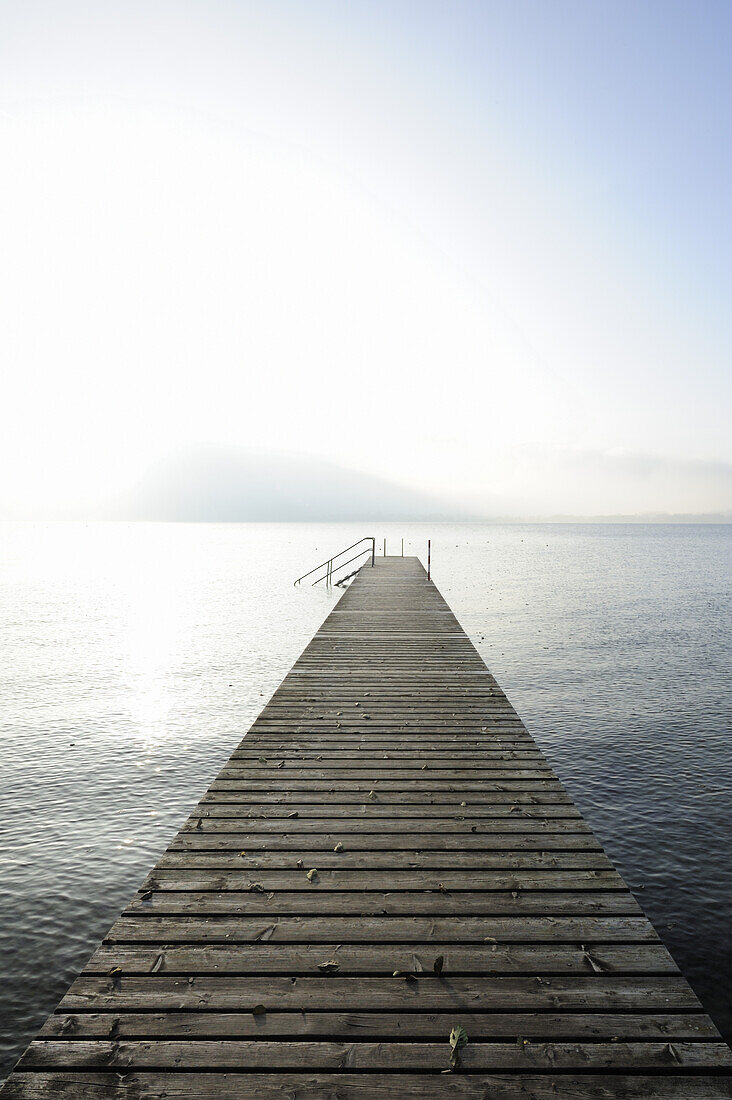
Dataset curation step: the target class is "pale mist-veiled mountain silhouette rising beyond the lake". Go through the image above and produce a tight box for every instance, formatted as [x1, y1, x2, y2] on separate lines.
[102, 447, 457, 523]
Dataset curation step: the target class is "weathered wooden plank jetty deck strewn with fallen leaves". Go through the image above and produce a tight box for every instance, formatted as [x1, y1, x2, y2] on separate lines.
[2, 558, 732, 1100]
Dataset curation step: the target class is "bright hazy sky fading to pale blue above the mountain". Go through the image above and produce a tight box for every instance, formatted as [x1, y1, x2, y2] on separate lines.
[0, 0, 732, 514]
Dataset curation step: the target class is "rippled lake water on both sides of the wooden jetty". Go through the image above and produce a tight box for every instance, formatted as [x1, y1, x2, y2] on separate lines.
[0, 524, 732, 1077]
